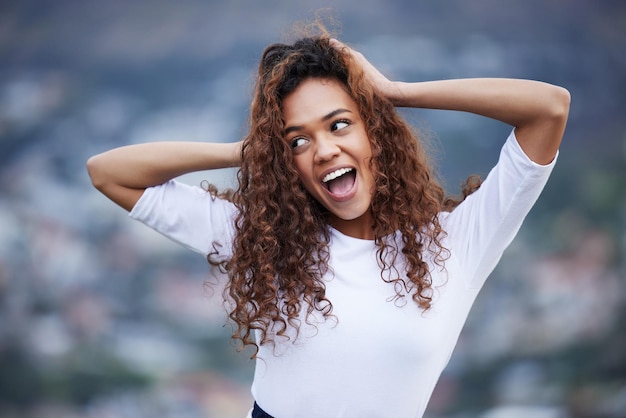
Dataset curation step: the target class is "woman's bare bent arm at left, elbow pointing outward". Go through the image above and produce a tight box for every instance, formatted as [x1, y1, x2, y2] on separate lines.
[87, 142, 241, 211]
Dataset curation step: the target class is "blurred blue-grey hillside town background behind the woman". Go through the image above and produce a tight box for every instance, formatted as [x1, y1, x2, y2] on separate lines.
[0, 0, 626, 418]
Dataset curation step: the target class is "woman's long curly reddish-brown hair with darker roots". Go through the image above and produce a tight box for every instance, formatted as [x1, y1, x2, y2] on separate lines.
[210, 34, 479, 355]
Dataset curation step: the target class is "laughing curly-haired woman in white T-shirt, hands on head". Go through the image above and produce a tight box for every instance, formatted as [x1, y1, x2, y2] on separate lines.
[87, 35, 569, 418]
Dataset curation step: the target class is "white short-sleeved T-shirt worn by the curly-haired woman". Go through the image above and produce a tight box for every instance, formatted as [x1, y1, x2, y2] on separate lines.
[130, 129, 556, 418]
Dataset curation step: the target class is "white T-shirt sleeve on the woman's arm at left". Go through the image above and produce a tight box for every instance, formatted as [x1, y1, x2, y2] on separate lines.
[129, 180, 236, 260]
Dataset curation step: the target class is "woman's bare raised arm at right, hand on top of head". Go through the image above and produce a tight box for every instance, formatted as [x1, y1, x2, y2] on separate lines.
[334, 41, 570, 164]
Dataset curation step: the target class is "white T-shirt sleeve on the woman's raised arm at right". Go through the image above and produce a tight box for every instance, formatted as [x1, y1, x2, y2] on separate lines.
[443, 131, 557, 289]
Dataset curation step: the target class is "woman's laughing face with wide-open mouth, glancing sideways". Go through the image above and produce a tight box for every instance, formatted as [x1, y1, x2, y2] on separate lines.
[283, 78, 374, 239]
